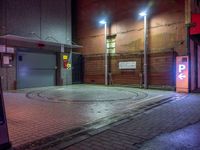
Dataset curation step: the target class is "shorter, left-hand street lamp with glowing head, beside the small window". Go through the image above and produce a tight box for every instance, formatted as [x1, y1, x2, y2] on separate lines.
[99, 20, 108, 85]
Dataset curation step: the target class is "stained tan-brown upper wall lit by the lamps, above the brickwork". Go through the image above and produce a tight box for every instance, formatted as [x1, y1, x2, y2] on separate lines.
[74, 0, 186, 55]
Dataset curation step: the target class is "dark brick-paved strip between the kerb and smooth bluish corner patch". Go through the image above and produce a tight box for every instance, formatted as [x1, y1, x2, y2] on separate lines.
[65, 94, 200, 150]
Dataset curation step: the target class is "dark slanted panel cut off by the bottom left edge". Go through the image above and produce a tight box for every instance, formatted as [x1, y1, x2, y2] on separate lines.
[0, 77, 11, 150]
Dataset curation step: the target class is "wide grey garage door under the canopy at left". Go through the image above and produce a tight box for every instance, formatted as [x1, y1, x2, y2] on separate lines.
[17, 52, 56, 89]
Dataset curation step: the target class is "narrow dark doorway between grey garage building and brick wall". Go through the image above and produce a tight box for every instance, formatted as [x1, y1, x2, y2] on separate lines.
[72, 53, 83, 84]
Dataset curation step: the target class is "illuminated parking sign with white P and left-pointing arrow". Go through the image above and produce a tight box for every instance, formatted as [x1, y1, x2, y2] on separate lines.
[176, 56, 189, 93]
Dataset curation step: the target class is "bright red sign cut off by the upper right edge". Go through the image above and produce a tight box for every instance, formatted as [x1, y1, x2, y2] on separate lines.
[190, 14, 200, 35]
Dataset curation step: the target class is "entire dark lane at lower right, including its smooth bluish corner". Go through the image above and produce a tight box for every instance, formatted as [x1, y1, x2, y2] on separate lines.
[65, 94, 200, 150]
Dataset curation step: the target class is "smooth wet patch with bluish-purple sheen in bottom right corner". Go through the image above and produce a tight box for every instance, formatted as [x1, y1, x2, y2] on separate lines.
[141, 122, 200, 150]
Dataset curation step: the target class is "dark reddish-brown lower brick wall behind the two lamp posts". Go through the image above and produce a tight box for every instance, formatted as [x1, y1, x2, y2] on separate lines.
[84, 51, 175, 86]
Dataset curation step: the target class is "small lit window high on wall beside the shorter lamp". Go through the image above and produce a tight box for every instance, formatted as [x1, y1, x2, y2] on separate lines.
[106, 35, 116, 54]
